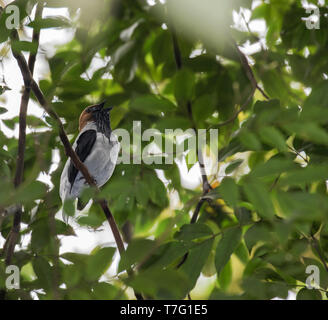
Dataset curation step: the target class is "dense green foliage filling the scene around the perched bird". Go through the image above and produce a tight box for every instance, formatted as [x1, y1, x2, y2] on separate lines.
[0, 0, 328, 299]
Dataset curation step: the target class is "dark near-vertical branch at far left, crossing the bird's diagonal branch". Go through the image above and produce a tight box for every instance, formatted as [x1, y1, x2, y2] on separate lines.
[4, 3, 43, 265]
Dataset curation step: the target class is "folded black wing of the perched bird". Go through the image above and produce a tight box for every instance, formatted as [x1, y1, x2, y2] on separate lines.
[68, 130, 97, 189]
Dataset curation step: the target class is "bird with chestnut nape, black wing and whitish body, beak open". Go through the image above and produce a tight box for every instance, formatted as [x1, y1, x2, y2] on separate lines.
[59, 102, 120, 216]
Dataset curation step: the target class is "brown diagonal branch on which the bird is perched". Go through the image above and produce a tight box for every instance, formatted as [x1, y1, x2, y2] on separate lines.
[9, 28, 143, 300]
